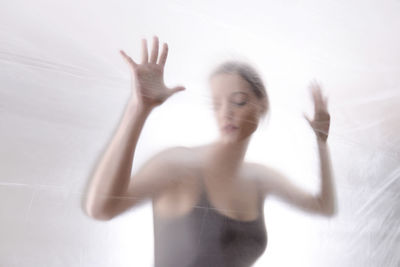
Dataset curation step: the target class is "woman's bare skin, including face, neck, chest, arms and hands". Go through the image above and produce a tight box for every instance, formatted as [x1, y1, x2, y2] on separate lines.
[84, 36, 336, 224]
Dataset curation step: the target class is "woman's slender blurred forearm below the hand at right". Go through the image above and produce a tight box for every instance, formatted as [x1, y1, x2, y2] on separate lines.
[317, 137, 337, 215]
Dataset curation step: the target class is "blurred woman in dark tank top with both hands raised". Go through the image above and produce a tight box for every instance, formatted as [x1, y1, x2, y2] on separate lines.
[85, 36, 335, 267]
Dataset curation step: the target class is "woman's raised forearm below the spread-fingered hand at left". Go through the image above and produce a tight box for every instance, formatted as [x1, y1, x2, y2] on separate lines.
[85, 100, 151, 220]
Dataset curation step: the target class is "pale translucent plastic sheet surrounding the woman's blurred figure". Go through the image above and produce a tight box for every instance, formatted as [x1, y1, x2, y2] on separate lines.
[0, 0, 400, 267]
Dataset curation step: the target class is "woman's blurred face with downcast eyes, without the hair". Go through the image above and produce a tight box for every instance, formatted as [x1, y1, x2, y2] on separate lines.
[210, 74, 262, 142]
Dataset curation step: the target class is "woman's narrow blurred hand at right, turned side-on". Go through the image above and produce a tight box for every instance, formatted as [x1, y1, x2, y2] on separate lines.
[303, 80, 330, 142]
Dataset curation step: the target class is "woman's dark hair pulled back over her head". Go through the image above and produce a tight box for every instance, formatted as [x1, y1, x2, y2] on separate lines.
[209, 60, 269, 120]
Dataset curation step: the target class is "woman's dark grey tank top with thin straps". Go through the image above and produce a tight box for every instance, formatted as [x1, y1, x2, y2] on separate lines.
[153, 179, 267, 267]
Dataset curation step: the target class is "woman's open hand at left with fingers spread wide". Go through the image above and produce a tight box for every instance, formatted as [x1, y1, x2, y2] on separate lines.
[120, 36, 185, 108]
